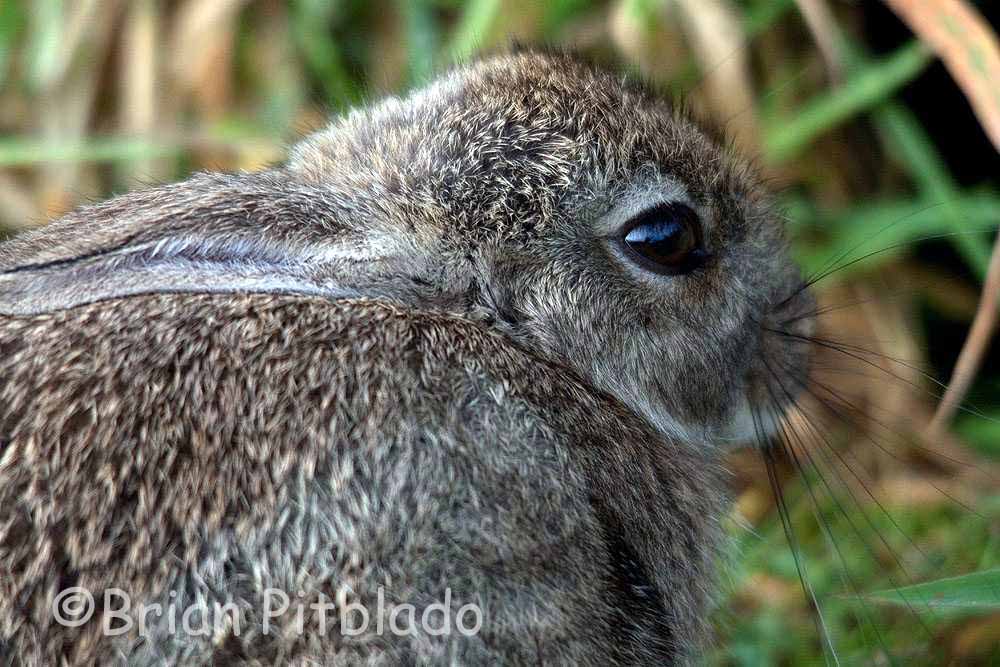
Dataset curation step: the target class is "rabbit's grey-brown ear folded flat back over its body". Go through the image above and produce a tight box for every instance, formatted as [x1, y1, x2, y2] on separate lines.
[0, 170, 458, 315]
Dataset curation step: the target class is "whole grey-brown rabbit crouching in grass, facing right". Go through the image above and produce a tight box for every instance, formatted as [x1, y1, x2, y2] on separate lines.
[0, 50, 812, 665]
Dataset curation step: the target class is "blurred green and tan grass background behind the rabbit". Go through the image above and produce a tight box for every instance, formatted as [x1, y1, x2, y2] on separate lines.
[0, 0, 1000, 665]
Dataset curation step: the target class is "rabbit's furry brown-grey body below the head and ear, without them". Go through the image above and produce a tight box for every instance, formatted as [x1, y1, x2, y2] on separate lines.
[0, 295, 714, 660]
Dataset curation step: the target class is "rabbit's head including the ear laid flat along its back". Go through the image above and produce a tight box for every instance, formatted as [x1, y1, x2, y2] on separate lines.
[0, 53, 809, 446]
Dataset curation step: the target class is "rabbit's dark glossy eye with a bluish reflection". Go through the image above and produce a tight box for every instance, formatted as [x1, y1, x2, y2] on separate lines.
[622, 203, 708, 275]
